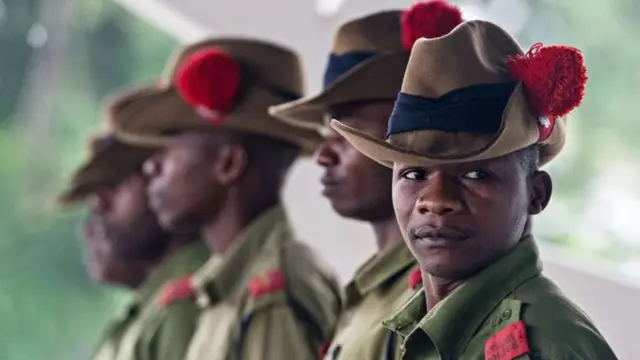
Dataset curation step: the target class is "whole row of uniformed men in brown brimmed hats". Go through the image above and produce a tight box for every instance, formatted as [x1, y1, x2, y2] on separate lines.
[60, 0, 615, 360]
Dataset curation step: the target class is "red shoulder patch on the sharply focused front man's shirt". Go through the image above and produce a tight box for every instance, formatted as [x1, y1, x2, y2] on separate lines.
[484, 320, 529, 360]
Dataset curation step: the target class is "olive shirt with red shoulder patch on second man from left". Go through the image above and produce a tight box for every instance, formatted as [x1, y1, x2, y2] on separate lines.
[187, 206, 341, 360]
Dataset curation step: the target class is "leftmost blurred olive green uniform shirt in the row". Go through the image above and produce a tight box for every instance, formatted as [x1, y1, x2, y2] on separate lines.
[93, 241, 209, 360]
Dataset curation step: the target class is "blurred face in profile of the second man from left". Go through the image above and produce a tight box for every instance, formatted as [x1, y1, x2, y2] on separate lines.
[144, 135, 223, 232]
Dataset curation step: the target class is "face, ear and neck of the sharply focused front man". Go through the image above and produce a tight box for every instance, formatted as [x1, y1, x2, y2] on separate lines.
[393, 154, 552, 309]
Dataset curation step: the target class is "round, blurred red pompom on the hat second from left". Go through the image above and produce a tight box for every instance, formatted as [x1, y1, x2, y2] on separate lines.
[176, 47, 240, 123]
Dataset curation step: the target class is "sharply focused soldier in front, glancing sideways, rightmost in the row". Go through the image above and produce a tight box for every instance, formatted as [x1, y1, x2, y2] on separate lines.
[332, 16, 616, 360]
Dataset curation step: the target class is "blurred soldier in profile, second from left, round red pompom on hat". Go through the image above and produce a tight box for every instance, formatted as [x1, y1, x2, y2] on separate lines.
[110, 39, 341, 360]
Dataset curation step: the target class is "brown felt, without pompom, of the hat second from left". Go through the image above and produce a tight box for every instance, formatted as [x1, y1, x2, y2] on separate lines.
[110, 38, 322, 155]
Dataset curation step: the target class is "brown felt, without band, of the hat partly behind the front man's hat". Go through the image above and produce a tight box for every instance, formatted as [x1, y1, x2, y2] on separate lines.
[269, 9, 409, 130]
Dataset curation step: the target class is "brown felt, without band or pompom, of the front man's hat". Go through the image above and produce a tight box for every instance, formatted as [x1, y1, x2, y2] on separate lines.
[331, 20, 586, 167]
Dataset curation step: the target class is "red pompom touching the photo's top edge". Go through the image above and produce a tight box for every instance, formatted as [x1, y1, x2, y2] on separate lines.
[400, 0, 462, 50]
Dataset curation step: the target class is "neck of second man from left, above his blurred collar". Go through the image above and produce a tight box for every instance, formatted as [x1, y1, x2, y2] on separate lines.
[201, 197, 277, 254]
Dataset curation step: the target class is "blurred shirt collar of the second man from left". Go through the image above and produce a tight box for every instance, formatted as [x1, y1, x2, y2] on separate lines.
[193, 205, 290, 305]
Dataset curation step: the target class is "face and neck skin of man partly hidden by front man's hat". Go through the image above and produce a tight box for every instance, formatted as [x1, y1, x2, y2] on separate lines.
[316, 101, 402, 252]
